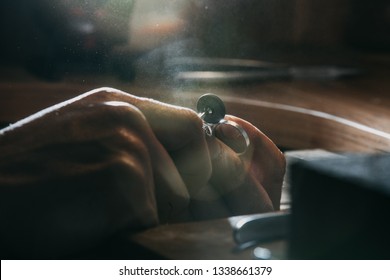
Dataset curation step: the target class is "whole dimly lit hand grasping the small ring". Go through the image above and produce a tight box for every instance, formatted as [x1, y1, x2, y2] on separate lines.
[0, 88, 285, 257]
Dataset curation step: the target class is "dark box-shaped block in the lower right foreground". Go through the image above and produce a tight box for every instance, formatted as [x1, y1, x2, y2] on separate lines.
[289, 155, 390, 260]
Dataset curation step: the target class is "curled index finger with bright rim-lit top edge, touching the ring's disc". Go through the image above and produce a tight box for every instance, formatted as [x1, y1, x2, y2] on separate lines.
[80, 88, 211, 196]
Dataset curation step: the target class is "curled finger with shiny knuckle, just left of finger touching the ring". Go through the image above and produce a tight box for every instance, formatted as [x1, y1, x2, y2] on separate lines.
[69, 101, 193, 223]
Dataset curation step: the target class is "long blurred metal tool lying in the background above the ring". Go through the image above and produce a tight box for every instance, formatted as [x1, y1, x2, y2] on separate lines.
[167, 57, 360, 83]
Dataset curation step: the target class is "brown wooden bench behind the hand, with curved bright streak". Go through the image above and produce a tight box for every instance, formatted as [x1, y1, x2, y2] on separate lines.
[0, 56, 390, 152]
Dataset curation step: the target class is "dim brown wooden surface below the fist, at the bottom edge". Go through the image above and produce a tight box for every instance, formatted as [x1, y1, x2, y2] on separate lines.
[131, 214, 287, 260]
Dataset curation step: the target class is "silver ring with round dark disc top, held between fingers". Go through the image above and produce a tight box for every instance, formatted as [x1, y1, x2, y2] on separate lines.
[196, 93, 250, 154]
